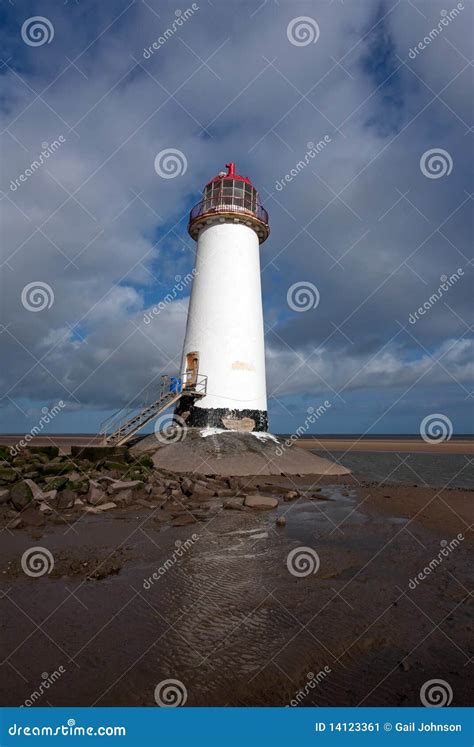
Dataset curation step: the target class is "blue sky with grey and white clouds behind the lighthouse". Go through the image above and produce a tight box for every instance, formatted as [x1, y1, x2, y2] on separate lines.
[0, 0, 474, 435]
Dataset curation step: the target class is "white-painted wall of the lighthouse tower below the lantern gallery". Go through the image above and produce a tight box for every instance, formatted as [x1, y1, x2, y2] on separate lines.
[183, 223, 267, 411]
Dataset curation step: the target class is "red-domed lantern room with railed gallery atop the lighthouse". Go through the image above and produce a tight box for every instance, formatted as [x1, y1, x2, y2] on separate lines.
[188, 163, 270, 243]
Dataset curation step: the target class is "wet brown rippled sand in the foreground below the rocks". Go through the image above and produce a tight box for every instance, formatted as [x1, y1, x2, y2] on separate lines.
[0, 476, 473, 706]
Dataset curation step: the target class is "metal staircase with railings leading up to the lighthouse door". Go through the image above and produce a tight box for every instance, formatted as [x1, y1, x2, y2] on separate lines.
[100, 375, 207, 446]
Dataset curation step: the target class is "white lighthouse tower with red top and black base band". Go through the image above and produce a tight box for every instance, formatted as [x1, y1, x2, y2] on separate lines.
[175, 163, 270, 432]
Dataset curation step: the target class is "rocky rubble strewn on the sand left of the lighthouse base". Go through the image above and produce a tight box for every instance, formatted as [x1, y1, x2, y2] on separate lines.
[0, 446, 326, 529]
